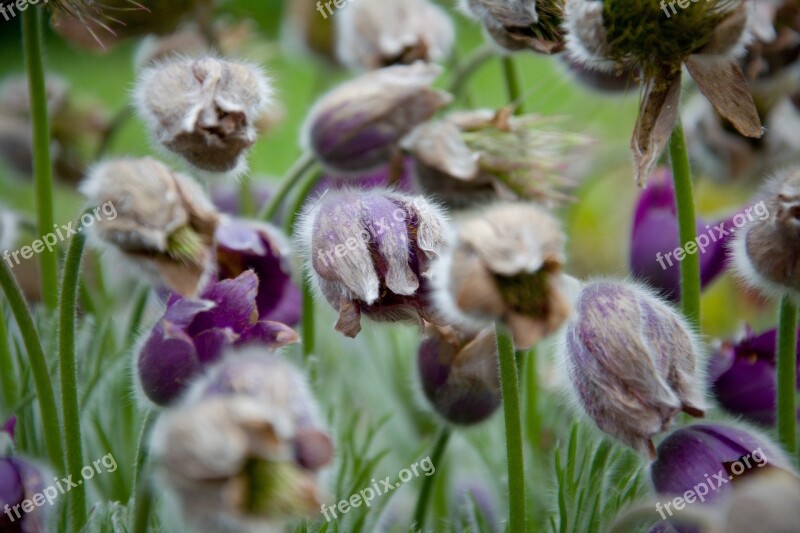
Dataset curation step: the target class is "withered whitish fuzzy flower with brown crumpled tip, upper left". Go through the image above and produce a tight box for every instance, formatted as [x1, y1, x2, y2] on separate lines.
[135, 57, 272, 172]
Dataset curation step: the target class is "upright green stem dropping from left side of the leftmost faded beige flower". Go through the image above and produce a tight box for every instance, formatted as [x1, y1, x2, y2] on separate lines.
[58, 233, 86, 531]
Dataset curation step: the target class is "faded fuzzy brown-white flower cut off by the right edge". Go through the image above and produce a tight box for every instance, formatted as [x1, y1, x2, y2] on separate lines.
[731, 167, 800, 298]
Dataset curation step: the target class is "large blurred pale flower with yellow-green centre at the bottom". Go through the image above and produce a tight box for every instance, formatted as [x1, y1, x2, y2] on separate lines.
[151, 347, 333, 531]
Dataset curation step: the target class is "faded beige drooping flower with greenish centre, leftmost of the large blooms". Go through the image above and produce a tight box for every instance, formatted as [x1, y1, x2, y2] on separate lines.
[80, 157, 219, 296]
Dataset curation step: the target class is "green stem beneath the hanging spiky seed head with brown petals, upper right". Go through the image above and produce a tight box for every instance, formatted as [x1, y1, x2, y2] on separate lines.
[669, 117, 700, 328]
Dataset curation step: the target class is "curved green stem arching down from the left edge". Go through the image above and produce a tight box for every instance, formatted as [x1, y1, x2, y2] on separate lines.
[0, 252, 64, 466]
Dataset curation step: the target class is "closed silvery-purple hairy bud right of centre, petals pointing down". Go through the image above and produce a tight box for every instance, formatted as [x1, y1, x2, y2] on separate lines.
[560, 281, 705, 458]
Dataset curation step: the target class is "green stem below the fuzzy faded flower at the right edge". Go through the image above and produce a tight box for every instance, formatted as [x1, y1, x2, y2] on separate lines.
[778, 295, 797, 456]
